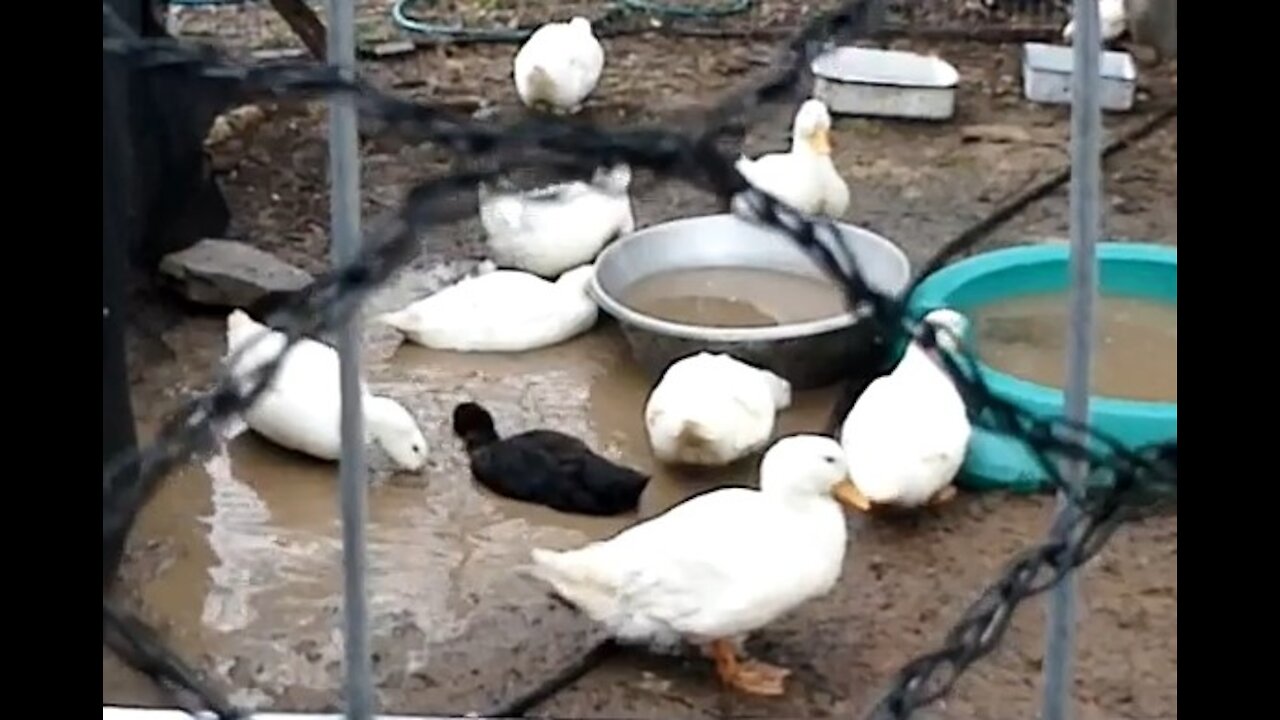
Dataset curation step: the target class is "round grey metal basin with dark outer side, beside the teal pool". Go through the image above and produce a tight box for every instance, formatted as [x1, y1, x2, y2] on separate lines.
[589, 214, 911, 389]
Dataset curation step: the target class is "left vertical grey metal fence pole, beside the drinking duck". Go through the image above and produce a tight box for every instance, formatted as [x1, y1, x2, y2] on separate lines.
[328, 0, 374, 720]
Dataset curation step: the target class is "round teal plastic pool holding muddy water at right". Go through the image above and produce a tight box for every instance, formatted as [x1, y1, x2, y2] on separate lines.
[909, 242, 1178, 492]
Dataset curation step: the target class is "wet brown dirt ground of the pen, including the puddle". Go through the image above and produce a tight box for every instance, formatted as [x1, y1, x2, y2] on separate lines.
[102, 3, 1178, 720]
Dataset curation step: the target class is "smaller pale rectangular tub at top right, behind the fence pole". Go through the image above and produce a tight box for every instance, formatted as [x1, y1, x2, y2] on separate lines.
[1023, 42, 1138, 111]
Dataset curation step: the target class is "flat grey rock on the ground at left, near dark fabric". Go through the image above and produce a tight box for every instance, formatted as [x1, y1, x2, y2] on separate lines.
[160, 238, 314, 307]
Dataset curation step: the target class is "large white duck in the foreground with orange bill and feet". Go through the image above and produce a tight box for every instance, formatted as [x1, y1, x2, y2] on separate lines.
[529, 434, 854, 696]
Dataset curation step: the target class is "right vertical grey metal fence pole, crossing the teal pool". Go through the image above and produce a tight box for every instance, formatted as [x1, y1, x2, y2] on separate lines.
[1043, 1, 1102, 720]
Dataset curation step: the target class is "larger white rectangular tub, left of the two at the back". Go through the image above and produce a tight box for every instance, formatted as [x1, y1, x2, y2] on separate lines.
[812, 47, 960, 120]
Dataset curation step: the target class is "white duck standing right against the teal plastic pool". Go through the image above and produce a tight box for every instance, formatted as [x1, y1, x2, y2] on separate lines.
[840, 307, 973, 511]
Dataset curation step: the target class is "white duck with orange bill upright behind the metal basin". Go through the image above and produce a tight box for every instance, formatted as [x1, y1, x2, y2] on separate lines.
[735, 99, 849, 218]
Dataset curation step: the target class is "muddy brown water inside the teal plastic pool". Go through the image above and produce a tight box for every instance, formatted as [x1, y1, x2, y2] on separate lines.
[972, 293, 1178, 402]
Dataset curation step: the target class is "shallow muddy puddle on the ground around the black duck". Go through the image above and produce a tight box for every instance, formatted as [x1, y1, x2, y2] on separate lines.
[124, 319, 835, 702]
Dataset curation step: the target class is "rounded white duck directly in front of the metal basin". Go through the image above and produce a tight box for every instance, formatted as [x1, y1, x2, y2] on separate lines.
[644, 352, 791, 465]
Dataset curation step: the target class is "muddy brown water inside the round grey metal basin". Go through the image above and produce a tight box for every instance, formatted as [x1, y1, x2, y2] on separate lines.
[622, 268, 845, 328]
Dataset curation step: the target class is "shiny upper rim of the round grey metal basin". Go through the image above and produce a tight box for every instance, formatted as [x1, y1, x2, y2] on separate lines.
[588, 213, 911, 342]
